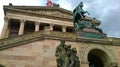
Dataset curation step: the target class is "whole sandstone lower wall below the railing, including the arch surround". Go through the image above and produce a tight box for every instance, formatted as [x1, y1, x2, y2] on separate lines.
[0, 39, 120, 67]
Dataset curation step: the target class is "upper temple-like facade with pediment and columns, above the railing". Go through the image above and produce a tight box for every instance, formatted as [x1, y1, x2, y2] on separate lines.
[2, 6, 73, 38]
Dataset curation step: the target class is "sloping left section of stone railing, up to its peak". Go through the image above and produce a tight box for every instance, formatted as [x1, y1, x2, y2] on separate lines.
[0, 32, 42, 50]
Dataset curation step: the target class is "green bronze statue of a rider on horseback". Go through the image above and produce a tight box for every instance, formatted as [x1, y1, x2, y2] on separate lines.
[73, 2, 103, 33]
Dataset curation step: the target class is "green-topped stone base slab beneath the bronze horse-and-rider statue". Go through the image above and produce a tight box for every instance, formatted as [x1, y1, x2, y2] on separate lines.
[76, 30, 109, 43]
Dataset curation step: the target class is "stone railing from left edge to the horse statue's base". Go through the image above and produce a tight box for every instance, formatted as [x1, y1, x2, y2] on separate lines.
[0, 30, 76, 50]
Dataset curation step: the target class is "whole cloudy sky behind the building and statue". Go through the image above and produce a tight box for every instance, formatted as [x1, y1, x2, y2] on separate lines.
[0, 0, 120, 38]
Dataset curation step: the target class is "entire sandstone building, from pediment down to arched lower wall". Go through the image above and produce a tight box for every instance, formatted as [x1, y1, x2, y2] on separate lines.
[0, 4, 120, 67]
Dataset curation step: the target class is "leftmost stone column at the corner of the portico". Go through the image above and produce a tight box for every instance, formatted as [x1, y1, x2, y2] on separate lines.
[1, 17, 10, 39]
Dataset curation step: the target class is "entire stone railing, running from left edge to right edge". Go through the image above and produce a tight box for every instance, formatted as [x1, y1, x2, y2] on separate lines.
[0, 30, 120, 50]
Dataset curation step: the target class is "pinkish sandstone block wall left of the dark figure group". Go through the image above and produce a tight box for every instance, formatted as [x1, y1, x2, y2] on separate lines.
[0, 40, 78, 67]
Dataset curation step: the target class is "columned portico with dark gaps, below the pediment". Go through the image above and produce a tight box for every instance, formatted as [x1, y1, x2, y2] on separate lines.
[1, 17, 73, 38]
